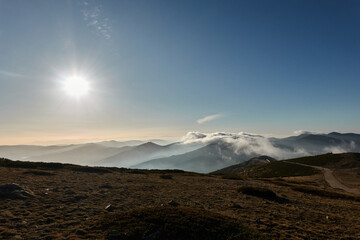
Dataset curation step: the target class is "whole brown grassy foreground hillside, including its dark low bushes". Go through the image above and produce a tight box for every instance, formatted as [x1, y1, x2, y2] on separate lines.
[0, 159, 360, 240]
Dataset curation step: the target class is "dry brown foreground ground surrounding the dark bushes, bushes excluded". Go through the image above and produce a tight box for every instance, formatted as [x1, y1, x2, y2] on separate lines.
[0, 167, 360, 239]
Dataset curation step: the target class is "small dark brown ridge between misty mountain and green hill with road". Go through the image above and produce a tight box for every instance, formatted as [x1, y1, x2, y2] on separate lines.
[212, 156, 276, 174]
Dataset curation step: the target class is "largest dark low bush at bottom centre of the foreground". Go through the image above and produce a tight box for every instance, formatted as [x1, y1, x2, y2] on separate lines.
[99, 207, 264, 240]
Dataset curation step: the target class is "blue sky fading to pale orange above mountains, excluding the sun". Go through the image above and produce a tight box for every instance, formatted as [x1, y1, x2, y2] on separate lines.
[0, 0, 360, 144]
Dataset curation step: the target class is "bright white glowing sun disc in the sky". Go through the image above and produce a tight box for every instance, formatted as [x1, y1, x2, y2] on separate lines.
[63, 76, 90, 98]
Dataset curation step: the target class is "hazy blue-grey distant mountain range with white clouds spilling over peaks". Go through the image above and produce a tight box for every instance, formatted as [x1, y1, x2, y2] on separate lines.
[0, 132, 360, 173]
